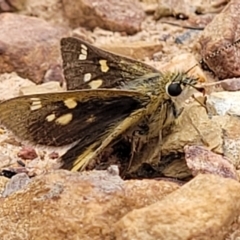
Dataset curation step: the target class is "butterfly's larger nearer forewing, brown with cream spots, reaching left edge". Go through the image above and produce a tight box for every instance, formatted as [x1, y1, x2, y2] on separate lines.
[0, 89, 149, 146]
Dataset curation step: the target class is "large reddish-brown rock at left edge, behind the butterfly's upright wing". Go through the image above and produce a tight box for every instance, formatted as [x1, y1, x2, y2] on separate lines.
[0, 13, 67, 83]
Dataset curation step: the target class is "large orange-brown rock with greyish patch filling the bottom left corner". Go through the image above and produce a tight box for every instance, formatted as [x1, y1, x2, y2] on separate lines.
[0, 170, 179, 240]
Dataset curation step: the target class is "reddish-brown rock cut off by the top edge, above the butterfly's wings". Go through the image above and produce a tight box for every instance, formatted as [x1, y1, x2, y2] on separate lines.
[63, 0, 145, 34]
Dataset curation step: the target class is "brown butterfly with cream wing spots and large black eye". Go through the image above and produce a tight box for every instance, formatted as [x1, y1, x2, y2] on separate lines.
[0, 37, 198, 176]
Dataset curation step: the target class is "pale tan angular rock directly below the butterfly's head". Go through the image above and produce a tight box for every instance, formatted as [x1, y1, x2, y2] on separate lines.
[162, 102, 223, 155]
